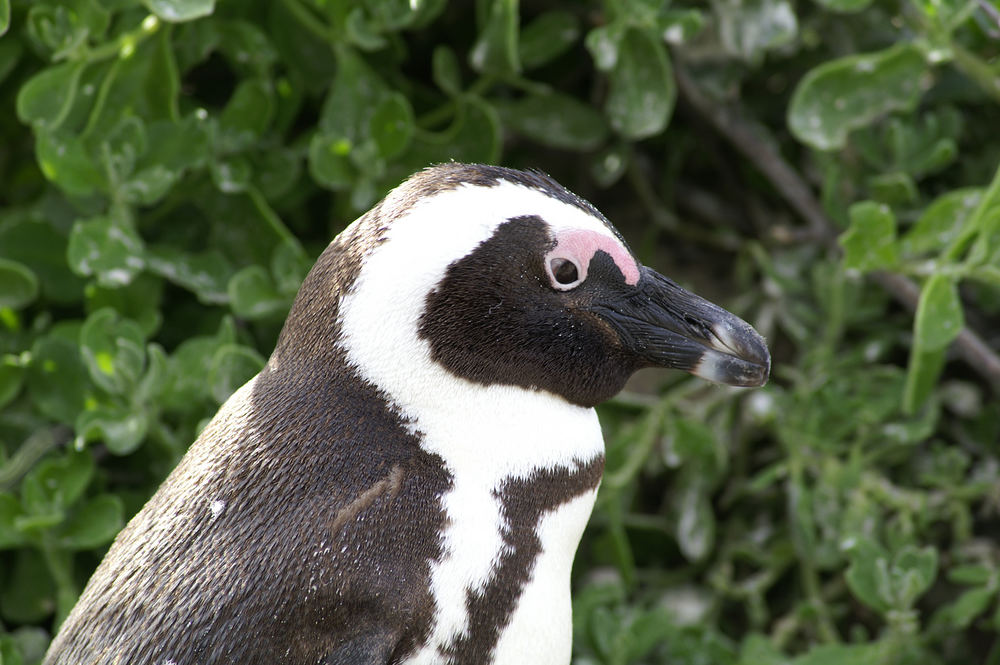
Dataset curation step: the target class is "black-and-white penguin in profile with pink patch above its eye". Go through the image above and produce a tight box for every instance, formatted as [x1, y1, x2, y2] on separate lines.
[44, 163, 770, 665]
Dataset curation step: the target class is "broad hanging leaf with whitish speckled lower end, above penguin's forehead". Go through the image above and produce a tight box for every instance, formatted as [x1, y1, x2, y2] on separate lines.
[604, 30, 677, 140]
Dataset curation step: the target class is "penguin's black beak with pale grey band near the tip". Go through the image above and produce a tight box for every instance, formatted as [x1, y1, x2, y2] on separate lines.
[590, 266, 771, 387]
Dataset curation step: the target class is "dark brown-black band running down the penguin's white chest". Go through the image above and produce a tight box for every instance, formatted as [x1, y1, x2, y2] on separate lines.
[448, 456, 604, 665]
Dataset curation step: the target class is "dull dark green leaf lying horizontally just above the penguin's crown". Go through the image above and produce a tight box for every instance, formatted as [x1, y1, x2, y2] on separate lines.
[500, 93, 608, 151]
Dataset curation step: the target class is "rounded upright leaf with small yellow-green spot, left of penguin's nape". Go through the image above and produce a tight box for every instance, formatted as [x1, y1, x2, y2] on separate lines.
[80, 308, 146, 396]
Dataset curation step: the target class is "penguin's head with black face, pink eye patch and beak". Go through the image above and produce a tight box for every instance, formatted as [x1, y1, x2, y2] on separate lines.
[279, 163, 770, 407]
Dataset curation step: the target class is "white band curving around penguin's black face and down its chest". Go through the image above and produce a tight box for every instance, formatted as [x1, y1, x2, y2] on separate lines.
[340, 176, 619, 663]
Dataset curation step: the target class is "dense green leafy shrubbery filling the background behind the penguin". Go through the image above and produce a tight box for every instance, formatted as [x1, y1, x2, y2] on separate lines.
[0, 0, 1000, 665]
